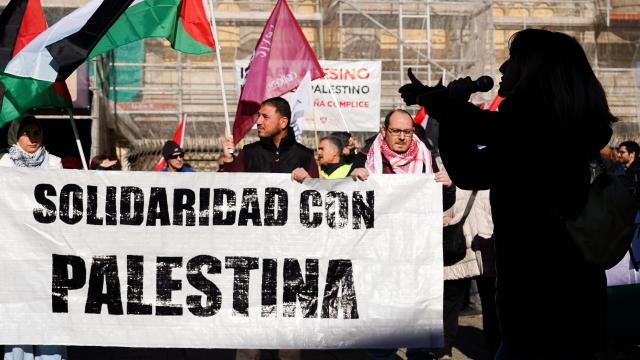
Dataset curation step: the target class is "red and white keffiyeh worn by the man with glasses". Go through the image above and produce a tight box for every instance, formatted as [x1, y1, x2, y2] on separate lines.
[365, 134, 433, 174]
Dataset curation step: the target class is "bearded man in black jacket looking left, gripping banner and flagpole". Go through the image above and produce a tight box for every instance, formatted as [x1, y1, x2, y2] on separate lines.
[220, 97, 318, 181]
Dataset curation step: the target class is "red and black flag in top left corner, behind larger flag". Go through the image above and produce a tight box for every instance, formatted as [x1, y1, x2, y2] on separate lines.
[0, 0, 71, 121]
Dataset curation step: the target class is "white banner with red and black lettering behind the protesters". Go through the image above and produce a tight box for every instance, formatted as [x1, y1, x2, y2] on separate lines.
[236, 59, 382, 132]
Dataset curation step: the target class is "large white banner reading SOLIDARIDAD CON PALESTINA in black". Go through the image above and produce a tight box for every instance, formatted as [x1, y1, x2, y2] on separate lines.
[0, 169, 443, 349]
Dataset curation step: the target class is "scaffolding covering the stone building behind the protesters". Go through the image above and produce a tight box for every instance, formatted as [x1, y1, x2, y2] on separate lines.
[85, 0, 640, 170]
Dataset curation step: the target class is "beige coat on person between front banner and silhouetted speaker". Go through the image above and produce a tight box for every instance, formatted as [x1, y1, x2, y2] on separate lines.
[444, 189, 495, 280]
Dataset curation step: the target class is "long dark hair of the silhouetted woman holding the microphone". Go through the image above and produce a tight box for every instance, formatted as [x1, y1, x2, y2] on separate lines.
[509, 29, 617, 156]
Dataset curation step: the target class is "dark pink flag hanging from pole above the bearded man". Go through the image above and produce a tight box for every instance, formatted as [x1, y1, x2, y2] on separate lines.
[233, 0, 324, 144]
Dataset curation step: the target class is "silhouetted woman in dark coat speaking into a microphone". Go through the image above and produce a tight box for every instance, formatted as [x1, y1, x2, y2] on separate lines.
[400, 29, 616, 360]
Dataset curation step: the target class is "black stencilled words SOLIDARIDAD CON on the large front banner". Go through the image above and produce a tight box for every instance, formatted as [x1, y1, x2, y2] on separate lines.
[33, 184, 375, 229]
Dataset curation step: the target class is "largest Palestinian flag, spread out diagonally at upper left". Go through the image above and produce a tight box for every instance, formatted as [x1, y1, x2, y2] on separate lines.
[0, 0, 215, 125]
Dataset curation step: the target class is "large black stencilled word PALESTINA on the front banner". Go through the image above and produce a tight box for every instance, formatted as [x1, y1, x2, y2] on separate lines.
[51, 254, 358, 319]
